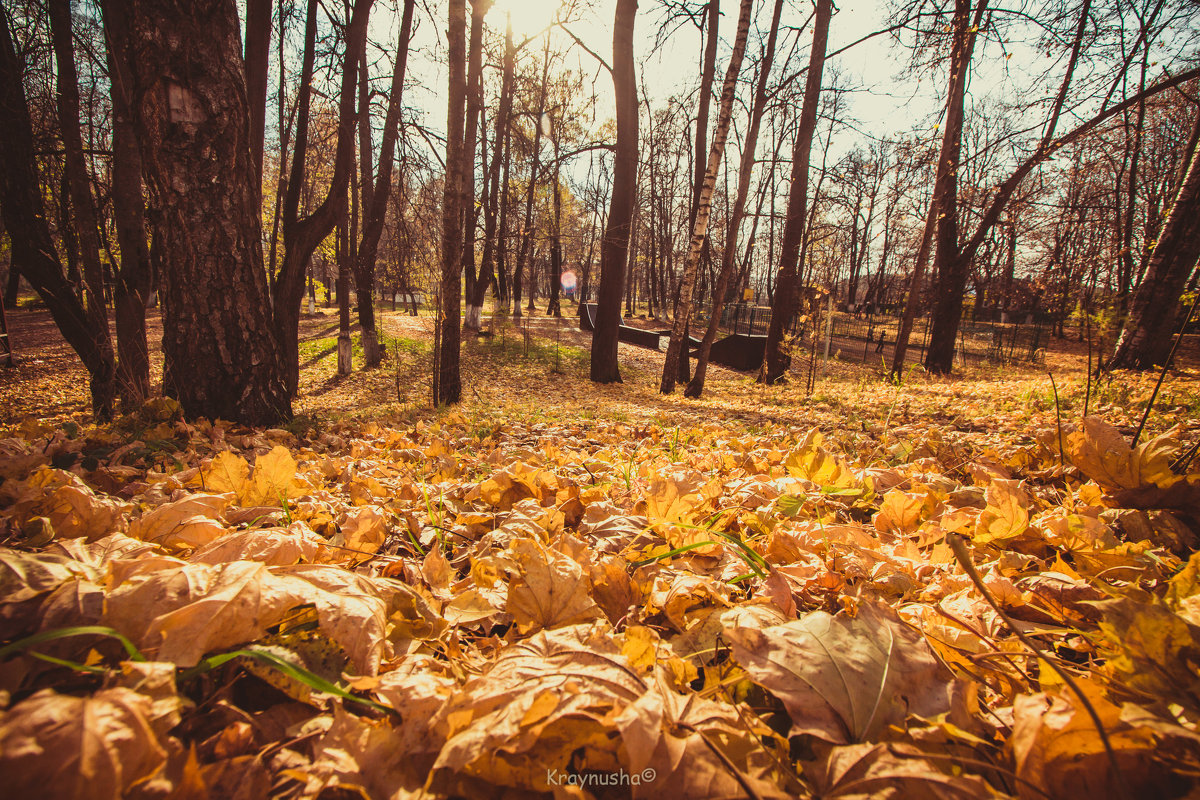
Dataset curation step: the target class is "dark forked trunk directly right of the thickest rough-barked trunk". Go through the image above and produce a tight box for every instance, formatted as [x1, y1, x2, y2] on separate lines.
[271, 0, 372, 397]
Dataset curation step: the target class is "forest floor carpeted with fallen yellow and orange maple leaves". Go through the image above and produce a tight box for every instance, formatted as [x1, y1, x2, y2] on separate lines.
[0, 302, 1200, 800]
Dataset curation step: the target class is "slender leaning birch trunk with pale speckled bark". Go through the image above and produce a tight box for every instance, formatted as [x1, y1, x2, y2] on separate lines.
[659, 0, 754, 395]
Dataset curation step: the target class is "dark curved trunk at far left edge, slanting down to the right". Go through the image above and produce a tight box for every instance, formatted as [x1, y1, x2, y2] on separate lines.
[0, 8, 114, 419]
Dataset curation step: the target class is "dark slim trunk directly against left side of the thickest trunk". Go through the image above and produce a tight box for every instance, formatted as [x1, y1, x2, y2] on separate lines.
[104, 1, 152, 411]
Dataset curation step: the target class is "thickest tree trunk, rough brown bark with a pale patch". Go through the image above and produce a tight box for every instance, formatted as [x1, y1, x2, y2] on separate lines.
[106, 0, 292, 425]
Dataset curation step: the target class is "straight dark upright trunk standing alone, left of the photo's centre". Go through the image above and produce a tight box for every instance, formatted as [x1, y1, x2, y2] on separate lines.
[433, 0, 468, 405]
